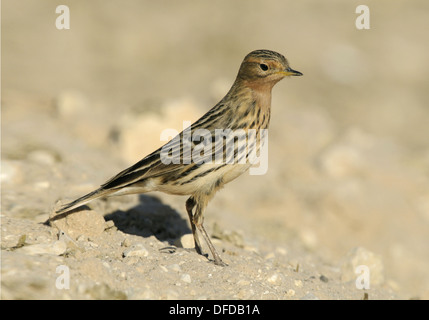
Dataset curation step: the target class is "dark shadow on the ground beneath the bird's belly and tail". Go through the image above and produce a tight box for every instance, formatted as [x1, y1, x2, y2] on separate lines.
[104, 194, 191, 245]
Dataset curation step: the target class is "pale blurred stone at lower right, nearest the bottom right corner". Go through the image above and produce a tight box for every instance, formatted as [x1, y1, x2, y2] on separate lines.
[341, 247, 384, 286]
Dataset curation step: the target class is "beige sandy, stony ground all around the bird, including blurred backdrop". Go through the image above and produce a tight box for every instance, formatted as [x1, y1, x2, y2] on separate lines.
[1, 0, 429, 299]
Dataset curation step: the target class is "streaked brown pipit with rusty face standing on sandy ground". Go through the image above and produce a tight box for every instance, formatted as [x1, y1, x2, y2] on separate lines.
[51, 50, 302, 266]
